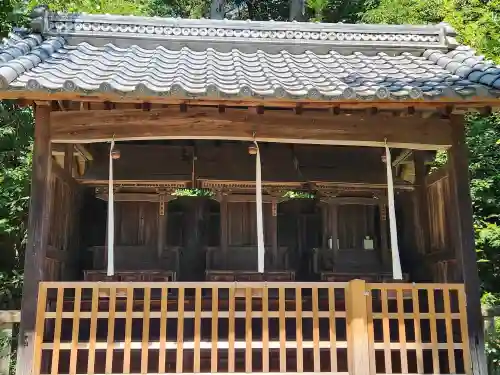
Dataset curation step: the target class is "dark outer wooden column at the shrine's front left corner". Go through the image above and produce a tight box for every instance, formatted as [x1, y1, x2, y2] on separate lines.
[17, 102, 52, 375]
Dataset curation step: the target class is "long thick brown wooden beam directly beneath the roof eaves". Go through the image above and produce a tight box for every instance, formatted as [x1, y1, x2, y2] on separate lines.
[51, 107, 451, 150]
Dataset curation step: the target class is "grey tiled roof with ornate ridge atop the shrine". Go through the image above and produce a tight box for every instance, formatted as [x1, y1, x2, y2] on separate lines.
[0, 6, 500, 100]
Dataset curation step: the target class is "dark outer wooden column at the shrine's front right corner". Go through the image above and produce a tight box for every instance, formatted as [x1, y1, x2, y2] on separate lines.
[448, 115, 487, 375]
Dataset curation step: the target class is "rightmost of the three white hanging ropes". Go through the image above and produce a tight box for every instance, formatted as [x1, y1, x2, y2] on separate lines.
[384, 139, 403, 280]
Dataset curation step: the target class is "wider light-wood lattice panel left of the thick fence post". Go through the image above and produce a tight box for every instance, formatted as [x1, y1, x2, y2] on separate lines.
[34, 282, 348, 375]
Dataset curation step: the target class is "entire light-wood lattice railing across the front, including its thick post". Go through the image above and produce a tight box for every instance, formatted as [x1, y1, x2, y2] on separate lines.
[33, 280, 471, 375]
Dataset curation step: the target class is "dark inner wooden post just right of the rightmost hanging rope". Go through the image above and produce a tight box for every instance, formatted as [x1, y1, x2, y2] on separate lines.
[413, 151, 430, 254]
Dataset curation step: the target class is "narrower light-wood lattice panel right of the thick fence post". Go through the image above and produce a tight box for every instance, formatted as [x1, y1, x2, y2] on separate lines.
[367, 283, 471, 374]
